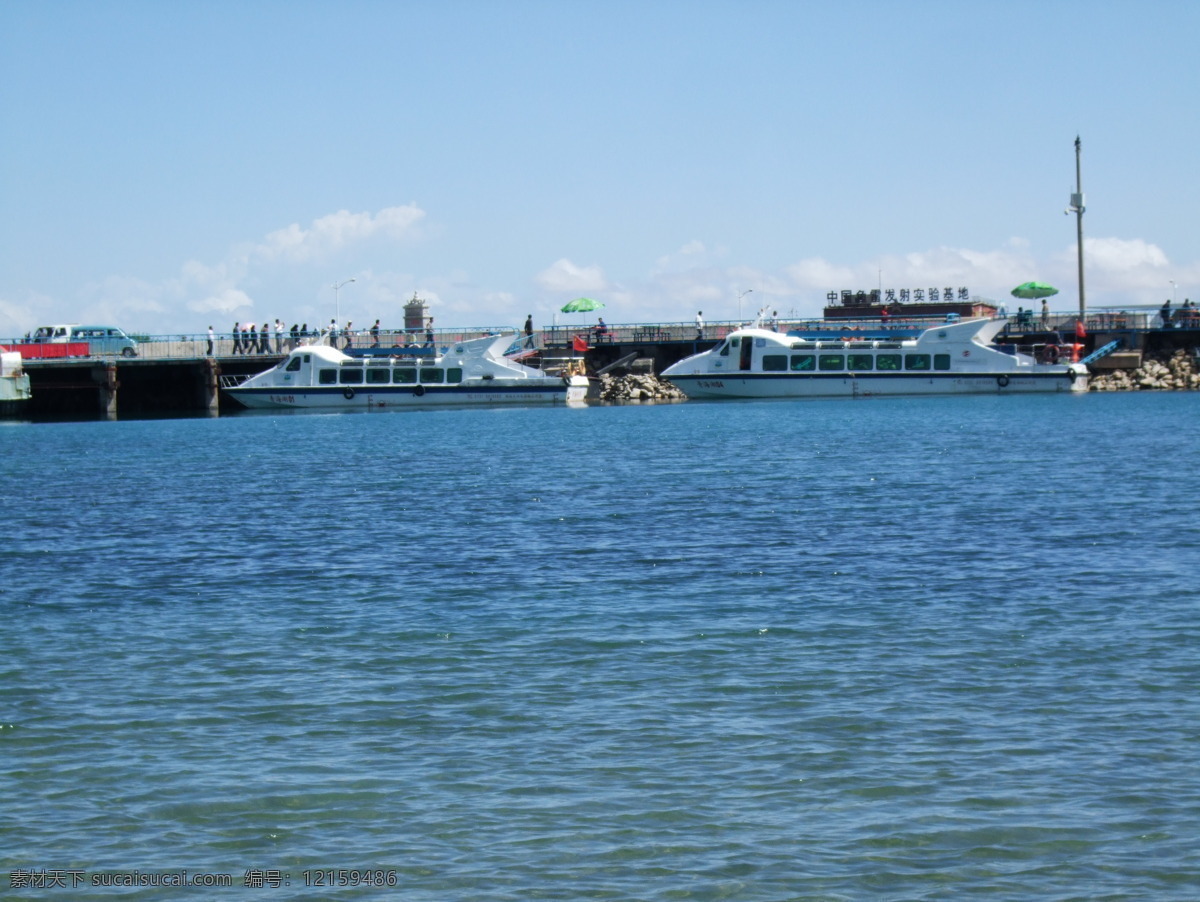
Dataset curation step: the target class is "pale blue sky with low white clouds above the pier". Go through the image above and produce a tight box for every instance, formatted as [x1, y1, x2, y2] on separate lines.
[0, 0, 1200, 336]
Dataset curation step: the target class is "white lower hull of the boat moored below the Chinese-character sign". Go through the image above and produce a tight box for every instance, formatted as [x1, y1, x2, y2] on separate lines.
[667, 371, 1087, 399]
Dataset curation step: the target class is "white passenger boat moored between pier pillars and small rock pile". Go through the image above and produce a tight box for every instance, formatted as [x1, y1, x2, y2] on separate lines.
[221, 333, 588, 410]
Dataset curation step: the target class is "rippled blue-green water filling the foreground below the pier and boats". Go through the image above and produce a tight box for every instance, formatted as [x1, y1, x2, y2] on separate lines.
[0, 393, 1200, 902]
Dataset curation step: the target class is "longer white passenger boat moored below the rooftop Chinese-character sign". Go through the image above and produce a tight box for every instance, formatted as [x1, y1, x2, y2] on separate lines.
[662, 319, 1087, 398]
